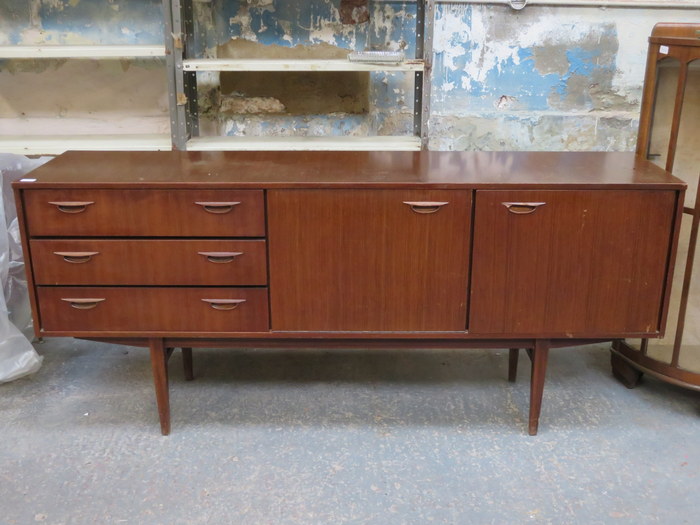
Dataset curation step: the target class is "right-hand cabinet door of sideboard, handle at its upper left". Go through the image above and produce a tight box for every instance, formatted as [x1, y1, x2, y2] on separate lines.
[469, 190, 676, 337]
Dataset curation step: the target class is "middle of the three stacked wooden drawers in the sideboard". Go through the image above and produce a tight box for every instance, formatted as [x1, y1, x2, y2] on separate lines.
[30, 239, 267, 286]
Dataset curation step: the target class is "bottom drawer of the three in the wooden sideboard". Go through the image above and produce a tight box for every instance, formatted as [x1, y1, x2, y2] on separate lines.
[37, 286, 269, 333]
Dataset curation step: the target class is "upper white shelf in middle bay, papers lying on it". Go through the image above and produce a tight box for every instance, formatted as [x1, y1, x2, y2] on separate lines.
[183, 58, 425, 71]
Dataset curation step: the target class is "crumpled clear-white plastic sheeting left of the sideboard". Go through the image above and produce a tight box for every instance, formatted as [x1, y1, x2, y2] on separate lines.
[0, 154, 50, 383]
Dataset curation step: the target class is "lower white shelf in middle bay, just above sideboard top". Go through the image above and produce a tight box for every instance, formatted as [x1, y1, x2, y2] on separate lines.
[187, 136, 421, 151]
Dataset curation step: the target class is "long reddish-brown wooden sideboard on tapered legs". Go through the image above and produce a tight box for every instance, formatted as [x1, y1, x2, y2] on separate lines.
[14, 151, 685, 434]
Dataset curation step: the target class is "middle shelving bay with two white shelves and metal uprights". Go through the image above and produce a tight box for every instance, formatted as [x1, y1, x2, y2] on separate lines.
[170, 0, 435, 151]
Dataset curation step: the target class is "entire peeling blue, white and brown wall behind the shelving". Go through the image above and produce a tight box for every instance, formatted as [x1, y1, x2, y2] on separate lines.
[0, 0, 700, 150]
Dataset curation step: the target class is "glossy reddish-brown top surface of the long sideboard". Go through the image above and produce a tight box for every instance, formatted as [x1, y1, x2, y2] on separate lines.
[14, 151, 685, 189]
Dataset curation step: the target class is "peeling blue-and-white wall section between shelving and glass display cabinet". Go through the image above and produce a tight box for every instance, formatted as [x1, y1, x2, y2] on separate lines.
[430, 4, 700, 150]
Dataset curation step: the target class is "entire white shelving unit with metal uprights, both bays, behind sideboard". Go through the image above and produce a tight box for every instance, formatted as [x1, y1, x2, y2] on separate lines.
[0, 0, 435, 155]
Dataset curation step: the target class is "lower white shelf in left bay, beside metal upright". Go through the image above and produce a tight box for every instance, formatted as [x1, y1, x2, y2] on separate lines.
[0, 134, 172, 155]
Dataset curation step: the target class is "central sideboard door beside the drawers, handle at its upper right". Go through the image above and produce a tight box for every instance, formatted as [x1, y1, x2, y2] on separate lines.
[268, 190, 471, 331]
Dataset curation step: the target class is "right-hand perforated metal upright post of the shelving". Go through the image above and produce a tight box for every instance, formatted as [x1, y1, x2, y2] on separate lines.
[413, 0, 435, 149]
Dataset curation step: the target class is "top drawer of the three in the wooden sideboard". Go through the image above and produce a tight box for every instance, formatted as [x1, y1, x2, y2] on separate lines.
[22, 189, 265, 237]
